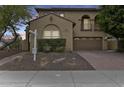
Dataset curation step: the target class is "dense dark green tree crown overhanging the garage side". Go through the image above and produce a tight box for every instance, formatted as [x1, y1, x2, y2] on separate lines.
[97, 5, 124, 40]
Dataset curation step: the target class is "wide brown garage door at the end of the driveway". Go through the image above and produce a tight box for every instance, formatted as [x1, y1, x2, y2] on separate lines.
[74, 37, 102, 50]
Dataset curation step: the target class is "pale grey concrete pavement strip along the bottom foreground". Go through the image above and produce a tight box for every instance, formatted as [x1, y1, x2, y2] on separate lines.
[0, 71, 124, 87]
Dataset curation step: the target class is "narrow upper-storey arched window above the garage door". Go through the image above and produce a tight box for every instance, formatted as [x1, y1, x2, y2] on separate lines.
[81, 15, 91, 31]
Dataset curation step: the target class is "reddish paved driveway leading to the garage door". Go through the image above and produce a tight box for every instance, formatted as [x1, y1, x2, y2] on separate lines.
[77, 51, 124, 70]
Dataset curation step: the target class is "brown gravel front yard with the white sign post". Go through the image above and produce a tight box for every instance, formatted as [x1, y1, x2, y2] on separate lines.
[0, 52, 95, 71]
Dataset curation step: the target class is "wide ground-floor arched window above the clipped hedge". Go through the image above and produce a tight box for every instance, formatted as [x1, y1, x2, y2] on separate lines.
[43, 25, 60, 39]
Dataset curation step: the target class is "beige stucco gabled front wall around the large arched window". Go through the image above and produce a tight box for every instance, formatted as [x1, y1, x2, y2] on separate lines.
[29, 14, 73, 51]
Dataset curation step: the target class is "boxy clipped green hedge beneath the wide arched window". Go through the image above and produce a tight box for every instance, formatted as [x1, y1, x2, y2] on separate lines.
[37, 39, 66, 52]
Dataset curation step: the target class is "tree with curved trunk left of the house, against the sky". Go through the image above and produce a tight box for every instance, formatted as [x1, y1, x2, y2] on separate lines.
[0, 5, 31, 48]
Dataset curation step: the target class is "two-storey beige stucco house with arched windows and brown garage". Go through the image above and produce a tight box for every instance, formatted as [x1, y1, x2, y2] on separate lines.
[29, 8, 114, 51]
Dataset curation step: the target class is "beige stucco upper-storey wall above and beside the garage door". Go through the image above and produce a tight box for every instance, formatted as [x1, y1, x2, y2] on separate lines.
[39, 11, 108, 50]
